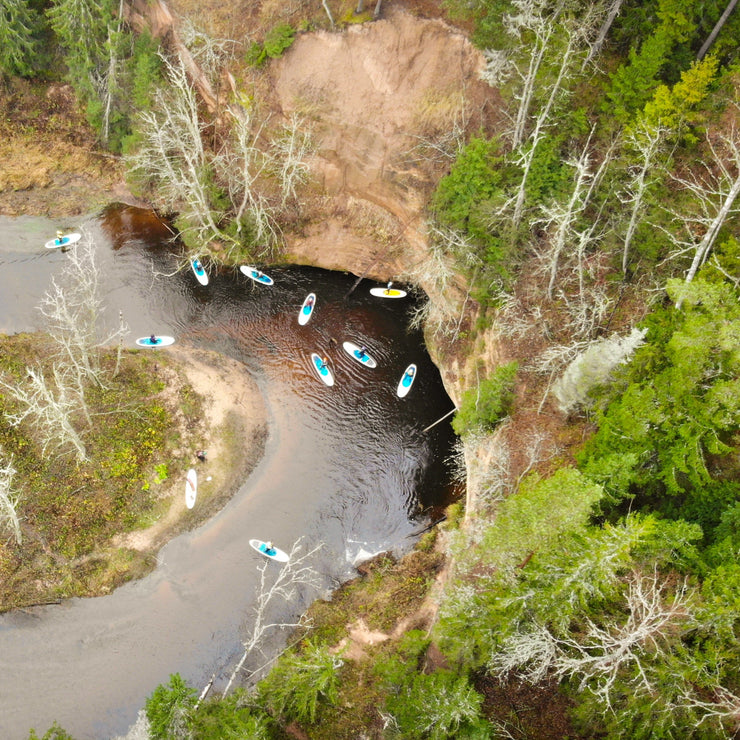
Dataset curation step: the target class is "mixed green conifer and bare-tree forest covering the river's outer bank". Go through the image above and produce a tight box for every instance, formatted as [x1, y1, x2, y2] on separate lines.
[0, 0, 740, 740]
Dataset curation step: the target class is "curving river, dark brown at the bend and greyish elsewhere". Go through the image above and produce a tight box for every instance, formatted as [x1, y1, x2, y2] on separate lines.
[0, 206, 453, 740]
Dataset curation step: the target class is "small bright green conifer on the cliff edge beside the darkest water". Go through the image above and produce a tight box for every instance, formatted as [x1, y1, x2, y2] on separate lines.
[452, 362, 519, 435]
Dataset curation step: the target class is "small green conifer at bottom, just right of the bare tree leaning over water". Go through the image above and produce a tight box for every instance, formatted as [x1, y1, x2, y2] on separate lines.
[259, 640, 342, 723]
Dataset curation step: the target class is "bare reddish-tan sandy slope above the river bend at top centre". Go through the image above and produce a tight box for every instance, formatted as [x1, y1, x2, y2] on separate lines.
[270, 11, 498, 279]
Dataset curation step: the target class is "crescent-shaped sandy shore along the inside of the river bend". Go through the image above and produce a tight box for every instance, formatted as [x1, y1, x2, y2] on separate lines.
[112, 344, 268, 552]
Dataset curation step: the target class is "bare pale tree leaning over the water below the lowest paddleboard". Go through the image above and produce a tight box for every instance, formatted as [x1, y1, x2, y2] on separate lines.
[223, 540, 323, 696]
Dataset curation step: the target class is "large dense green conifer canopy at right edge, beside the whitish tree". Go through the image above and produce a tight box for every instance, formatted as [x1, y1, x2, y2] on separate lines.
[580, 280, 740, 534]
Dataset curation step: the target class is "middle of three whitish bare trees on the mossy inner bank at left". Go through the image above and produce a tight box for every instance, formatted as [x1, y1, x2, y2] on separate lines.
[0, 365, 87, 462]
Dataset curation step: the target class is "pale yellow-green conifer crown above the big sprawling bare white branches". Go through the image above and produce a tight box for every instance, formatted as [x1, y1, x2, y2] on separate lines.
[435, 468, 604, 667]
